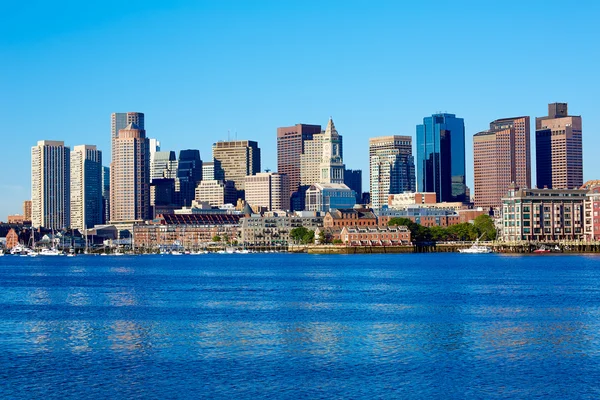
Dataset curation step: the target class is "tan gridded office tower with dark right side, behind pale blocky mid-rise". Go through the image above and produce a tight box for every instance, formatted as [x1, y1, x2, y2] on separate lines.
[213, 140, 260, 198]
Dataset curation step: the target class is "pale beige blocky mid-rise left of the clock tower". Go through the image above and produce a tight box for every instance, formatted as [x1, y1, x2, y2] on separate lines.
[245, 172, 290, 211]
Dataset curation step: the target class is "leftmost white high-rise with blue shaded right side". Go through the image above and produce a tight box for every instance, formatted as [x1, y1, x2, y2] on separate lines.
[31, 140, 71, 229]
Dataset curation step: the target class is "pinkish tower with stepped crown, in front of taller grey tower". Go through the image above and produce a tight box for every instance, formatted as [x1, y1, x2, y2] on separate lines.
[110, 123, 150, 223]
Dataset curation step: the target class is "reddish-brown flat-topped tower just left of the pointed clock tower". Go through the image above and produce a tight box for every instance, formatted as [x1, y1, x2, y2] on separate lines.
[277, 124, 321, 195]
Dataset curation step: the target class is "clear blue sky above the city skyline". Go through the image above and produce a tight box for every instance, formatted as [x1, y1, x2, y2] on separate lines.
[0, 0, 600, 220]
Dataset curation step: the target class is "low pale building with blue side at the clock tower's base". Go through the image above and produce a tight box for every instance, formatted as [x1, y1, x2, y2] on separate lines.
[305, 183, 356, 213]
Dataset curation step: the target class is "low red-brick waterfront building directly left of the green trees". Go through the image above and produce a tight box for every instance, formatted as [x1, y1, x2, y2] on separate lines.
[340, 226, 411, 246]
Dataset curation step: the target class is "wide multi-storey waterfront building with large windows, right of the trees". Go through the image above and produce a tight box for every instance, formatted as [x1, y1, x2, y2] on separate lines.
[502, 185, 588, 242]
